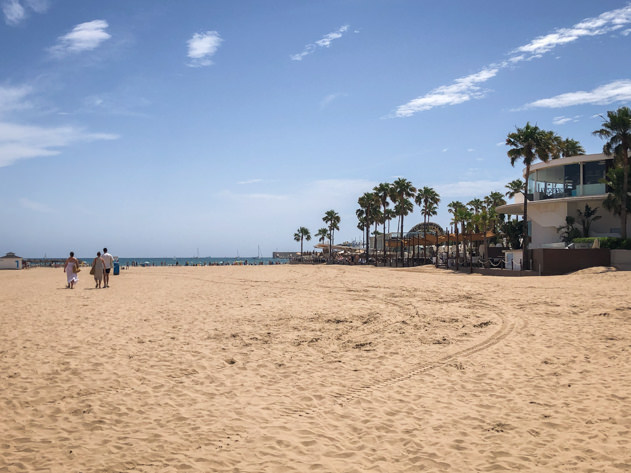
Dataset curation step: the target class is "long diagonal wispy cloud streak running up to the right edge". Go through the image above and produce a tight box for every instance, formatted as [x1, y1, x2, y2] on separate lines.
[393, 4, 631, 117]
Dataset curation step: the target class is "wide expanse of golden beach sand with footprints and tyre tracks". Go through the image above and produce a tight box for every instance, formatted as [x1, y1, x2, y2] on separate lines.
[0, 265, 631, 473]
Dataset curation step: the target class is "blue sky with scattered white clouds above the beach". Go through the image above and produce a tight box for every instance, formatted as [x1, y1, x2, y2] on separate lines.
[0, 0, 631, 256]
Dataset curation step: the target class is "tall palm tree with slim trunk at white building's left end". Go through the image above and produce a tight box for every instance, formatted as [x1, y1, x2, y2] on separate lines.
[506, 122, 561, 269]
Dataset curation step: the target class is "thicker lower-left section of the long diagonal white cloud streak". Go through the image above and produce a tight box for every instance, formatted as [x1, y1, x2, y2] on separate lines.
[394, 67, 498, 117]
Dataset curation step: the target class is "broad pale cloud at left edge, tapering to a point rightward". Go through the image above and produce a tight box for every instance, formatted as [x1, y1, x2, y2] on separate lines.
[0, 122, 118, 167]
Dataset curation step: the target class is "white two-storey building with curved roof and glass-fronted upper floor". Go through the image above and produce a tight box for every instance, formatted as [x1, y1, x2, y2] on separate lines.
[497, 154, 631, 249]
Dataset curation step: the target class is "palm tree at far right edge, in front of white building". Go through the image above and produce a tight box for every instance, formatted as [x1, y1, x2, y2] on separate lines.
[593, 107, 631, 239]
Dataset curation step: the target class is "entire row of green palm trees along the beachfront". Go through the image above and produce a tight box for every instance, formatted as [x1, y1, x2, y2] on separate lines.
[294, 107, 631, 269]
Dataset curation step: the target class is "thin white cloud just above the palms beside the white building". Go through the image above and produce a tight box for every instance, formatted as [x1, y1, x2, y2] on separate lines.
[526, 79, 631, 108]
